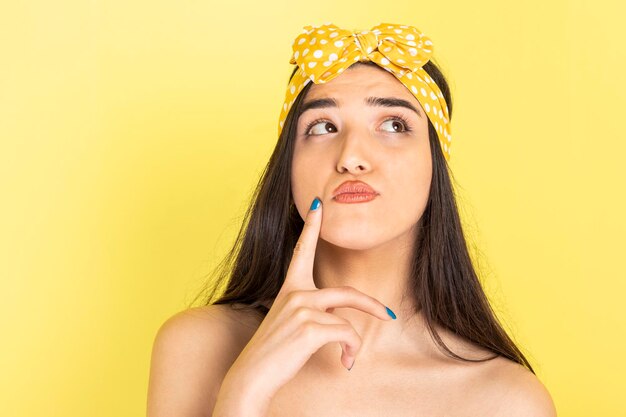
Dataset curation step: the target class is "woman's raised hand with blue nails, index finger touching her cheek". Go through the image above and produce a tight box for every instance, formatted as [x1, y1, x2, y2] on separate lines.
[215, 197, 391, 416]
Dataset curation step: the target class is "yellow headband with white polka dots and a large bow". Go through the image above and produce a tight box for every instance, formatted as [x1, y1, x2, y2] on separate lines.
[278, 23, 452, 160]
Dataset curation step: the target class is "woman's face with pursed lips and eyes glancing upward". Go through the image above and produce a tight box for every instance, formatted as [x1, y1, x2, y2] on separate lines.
[291, 65, 432, 250]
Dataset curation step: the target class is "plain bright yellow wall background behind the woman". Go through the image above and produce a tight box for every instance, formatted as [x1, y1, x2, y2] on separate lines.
[0, 0, 626, 417]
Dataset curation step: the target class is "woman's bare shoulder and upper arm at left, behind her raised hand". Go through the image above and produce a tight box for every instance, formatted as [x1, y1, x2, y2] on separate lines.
[147, 305, 255, 417]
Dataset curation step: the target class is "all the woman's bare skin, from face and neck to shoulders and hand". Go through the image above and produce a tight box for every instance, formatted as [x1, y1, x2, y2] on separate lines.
[149, 62, 556, 417]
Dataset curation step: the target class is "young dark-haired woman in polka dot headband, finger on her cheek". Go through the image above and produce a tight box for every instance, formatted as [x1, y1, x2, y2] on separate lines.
[148, 23, 556, 417]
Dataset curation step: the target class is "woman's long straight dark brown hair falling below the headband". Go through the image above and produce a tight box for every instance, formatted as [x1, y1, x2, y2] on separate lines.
[191, 60, 535, 374]
